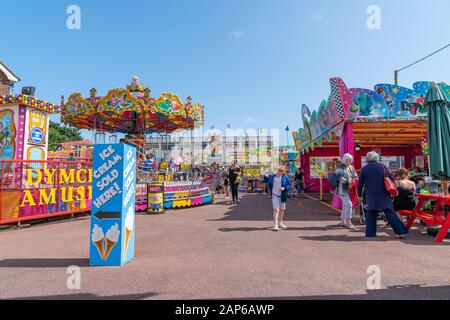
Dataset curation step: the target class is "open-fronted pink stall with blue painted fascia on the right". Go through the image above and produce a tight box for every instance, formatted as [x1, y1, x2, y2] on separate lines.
[293, 78, 450, 192]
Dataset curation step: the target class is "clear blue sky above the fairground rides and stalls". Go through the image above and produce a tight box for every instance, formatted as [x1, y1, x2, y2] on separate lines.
[0, 0, 450, 142]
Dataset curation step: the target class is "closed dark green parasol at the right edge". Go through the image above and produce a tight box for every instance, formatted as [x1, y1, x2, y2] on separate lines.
[425, 82, 450, 179]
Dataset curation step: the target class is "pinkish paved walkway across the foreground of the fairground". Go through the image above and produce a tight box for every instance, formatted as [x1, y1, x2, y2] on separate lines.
[0, 195, 450, 299]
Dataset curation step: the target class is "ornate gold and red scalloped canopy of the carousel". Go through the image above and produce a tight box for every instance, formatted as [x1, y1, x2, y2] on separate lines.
[61, 77, 204, 134]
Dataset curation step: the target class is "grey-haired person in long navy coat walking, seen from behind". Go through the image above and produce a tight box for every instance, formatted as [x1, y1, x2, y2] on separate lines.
[358, 151, 409, 239]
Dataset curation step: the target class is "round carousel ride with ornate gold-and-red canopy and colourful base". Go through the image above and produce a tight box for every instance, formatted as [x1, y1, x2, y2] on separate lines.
[61, 77, 213, 212]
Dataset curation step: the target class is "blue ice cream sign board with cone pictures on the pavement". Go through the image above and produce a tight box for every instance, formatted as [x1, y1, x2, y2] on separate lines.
[90, 144, 136, 266]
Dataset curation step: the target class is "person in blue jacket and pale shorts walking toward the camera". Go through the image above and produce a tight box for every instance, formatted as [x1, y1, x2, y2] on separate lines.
[269, 167, 291, 231]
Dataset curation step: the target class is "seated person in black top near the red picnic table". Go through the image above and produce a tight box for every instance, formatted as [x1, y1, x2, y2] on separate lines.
[394, 168, 416, 211]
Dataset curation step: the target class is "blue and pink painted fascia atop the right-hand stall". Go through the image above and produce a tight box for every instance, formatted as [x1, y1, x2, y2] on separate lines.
[293, 78, 450, 152]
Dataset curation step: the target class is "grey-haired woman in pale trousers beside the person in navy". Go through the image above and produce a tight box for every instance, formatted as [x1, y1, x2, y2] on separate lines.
[336, 153, 358, 230]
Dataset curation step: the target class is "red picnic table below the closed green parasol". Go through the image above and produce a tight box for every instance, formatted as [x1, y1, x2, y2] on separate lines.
[399, 194, 450, 243]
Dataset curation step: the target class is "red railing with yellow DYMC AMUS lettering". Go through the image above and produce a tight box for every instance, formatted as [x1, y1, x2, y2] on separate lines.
[0, 160, 92, 225]
